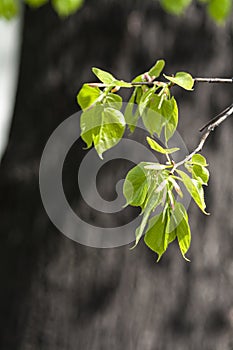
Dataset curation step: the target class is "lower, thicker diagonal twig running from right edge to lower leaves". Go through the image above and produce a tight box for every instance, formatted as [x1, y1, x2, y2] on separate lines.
[171, 104, 233, 173]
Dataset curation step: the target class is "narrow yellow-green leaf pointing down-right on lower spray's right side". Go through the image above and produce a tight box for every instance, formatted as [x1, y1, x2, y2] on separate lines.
[176, 169, 208, 215]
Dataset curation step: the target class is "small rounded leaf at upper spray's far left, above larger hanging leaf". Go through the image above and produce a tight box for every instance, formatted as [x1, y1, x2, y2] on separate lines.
[77, 84, 104, 111]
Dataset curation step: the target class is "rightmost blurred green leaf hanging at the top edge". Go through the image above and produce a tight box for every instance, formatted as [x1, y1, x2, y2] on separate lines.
[208, 0, 232, 24]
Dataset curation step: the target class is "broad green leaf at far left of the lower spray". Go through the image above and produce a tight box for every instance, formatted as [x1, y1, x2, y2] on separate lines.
[123, 162, 148, 206]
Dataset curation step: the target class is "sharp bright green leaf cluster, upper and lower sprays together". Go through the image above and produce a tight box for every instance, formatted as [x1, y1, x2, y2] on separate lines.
[77, 60, 209, 260]
